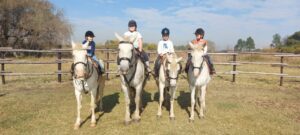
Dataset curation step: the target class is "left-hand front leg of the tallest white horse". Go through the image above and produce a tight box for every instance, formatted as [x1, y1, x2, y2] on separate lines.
[122, 84, 131, 125]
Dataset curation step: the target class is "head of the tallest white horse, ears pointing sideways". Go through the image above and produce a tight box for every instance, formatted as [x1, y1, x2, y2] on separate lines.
[115, 33, 134, 74]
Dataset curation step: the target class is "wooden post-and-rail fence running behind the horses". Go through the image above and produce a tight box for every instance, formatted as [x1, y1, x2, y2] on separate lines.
[0, 47, 300, 86]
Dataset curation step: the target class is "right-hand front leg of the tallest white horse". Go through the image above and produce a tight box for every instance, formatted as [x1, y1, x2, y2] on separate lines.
[133, 83, 143, 122]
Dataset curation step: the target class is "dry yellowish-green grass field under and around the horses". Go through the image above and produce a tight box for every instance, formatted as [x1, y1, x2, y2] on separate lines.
[0, 55, 300, 135]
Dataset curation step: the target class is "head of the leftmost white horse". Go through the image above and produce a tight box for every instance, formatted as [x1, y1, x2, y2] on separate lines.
[72, 41, 88, 79]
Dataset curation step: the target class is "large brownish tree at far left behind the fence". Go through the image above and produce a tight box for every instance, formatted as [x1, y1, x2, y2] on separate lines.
[0, 0, 72, 49]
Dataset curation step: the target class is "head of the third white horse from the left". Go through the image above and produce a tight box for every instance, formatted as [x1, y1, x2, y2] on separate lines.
[166, 53, 182, 87]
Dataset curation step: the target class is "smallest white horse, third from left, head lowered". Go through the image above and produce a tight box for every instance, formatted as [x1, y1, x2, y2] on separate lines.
[156, 53, 182, 120]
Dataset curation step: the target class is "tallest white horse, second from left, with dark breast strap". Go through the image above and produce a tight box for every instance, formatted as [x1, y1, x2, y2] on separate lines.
[115, 33, 146, 125]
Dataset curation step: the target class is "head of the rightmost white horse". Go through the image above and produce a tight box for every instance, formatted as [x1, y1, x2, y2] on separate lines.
[189, 42, 204, 77]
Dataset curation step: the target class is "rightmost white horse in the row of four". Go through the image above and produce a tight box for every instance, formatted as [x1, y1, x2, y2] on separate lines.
[187, 42, 211, 121]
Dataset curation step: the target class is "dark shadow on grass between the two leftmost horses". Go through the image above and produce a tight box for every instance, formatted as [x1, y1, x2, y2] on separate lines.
[80, 92, 120, 126]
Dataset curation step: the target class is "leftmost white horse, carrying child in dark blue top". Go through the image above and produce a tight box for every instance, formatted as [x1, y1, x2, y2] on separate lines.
[72, 42, 105, 129]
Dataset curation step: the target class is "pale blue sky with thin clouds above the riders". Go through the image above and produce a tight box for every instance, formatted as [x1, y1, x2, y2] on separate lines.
[49, 0, 300, 50]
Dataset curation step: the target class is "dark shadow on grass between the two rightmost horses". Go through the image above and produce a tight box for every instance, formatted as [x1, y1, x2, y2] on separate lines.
[177, 91, 191, 115]
